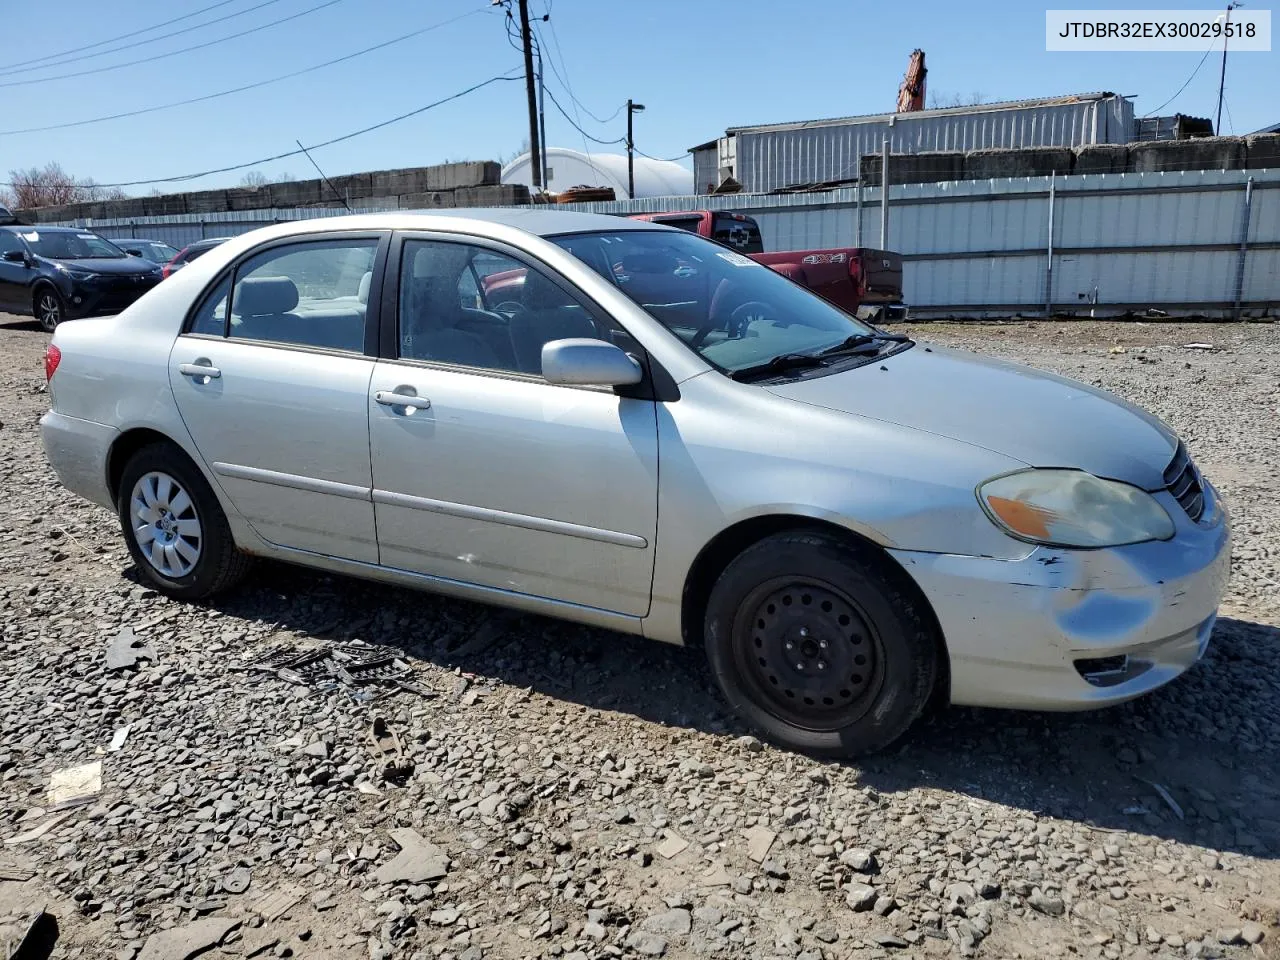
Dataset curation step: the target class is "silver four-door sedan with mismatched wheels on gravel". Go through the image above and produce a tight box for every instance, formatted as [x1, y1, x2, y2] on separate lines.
[42, 210, 1230, 755]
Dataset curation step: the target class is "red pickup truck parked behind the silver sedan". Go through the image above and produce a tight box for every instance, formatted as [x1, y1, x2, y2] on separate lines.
[630, 210, 908, 323]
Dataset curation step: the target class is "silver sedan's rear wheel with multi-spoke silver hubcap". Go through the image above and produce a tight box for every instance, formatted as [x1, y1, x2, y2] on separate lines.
[116, 443, 252, 600]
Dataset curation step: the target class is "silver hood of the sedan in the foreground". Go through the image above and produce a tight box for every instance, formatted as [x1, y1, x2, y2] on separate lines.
[769, 346, 1178, 490]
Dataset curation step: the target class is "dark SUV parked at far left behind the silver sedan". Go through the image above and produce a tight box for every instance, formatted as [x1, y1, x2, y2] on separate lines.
[0, 227, 161, 330]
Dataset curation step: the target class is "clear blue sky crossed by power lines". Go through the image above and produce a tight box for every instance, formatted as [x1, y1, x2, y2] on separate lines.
[0, 0, 1280, 193]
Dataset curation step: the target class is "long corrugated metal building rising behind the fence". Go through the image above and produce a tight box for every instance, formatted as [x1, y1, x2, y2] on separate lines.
[691, 92, 1134, 193]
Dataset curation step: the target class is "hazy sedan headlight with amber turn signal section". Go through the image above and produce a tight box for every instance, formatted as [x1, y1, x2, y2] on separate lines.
[978, 470, 1174, 547]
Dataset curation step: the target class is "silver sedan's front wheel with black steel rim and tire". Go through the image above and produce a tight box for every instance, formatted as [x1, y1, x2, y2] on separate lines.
[704, 530, 942, 758]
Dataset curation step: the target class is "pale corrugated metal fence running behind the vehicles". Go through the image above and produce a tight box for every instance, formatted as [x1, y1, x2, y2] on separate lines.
[55, 163, 1280, 316]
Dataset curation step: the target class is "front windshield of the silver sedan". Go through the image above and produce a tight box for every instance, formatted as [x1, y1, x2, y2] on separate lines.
[550, 230, 877, 374]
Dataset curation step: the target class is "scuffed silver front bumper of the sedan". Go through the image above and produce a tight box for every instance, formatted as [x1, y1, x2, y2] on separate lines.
[891, 483, 1231, 710]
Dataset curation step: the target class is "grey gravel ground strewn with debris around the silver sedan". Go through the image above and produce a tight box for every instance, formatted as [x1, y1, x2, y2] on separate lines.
[0, 317, 1280, 960]
